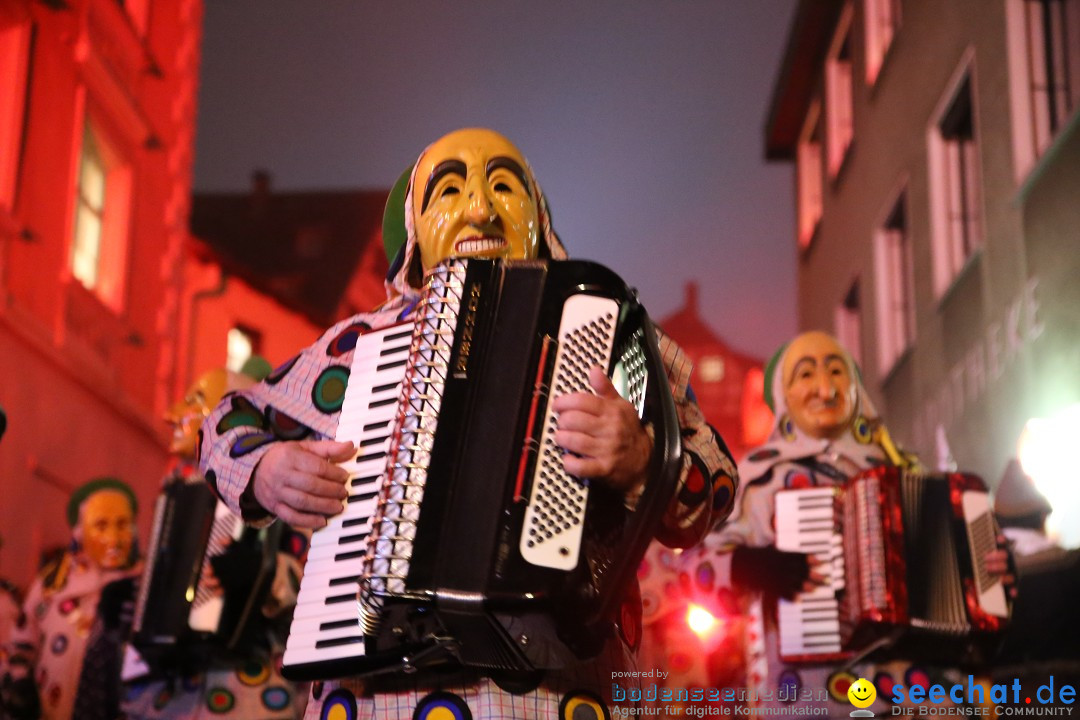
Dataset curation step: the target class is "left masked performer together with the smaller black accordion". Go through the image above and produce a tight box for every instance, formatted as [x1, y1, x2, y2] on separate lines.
[123, 369, 307, 720]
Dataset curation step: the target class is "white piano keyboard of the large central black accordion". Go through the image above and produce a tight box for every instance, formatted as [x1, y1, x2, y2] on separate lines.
[284, 323, 413, 665]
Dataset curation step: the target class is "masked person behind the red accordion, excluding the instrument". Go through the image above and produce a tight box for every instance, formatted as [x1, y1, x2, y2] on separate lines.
[680, 331, 1007, 717]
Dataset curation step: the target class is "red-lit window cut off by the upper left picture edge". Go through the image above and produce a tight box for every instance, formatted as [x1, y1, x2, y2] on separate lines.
[0, 23, 31, 213]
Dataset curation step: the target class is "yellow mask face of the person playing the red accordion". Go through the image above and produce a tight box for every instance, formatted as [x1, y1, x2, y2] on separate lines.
[783, 332, 855, 438]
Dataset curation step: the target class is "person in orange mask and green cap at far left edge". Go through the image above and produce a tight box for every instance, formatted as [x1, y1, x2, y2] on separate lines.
[3, 477, 139, 719]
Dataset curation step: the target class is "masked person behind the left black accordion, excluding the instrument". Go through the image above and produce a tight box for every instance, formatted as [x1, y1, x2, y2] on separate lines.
[122, 357, 307, 720]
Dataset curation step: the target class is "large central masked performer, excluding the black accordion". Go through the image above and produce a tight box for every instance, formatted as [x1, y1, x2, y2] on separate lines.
[202, 130, 734, 720]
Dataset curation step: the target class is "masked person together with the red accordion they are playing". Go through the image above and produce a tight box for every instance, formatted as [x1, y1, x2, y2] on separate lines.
[680, 331, 1010, 717]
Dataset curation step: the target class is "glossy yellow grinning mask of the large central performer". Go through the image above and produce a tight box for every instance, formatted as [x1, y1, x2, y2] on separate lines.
[411, 128, 539, 270]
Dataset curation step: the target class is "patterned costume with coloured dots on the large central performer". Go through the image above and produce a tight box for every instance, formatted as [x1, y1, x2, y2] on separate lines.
[201, 134, 737, 720]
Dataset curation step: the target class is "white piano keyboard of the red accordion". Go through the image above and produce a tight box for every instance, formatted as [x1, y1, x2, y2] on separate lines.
[775, 488, 843, 660]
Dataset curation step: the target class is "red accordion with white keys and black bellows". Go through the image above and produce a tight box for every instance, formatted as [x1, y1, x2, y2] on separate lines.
[775, 467, 1011, 662]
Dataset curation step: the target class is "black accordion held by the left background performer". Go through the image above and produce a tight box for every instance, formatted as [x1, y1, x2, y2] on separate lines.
[132, 474, 281, 668]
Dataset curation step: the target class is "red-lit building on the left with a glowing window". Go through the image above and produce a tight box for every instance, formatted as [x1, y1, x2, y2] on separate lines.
[0, 0, 203, 583]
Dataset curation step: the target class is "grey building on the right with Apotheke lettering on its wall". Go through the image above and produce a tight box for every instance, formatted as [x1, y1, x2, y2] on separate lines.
[766, 0, 1080, 505]
